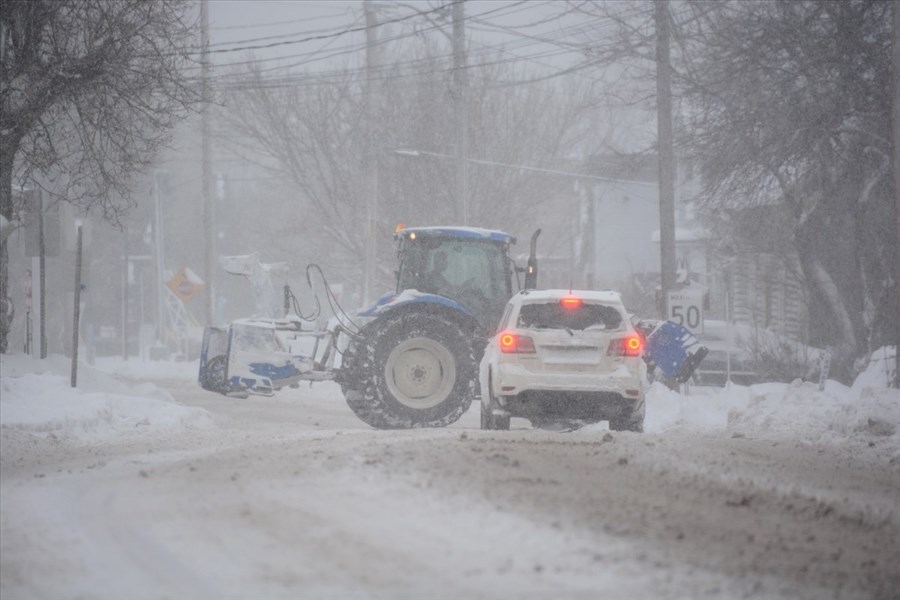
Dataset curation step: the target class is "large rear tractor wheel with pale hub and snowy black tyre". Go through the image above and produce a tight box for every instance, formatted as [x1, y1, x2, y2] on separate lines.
[344, 313, 476, 429]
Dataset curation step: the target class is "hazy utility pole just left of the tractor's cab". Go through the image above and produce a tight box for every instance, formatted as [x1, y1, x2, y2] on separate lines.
[362, 0, 378, 306]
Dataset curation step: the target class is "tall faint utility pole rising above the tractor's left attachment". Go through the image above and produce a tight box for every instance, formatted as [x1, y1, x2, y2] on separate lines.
[200, 0, 216, 325]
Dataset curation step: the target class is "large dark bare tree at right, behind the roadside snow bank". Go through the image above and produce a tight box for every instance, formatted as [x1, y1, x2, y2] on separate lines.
[680, 1, 898, 379]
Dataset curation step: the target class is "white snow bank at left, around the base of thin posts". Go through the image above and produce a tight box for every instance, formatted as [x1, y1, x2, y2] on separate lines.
[0, 355, 212, 441]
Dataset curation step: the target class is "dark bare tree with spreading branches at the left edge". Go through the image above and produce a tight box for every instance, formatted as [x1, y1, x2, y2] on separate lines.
[0, 0, 201, 352]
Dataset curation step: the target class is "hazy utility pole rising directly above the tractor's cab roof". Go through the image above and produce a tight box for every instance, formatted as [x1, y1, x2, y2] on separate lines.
[453, 0, 469, 225]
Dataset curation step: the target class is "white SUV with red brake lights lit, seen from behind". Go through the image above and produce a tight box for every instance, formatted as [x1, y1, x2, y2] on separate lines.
[479, 290, 646, 431]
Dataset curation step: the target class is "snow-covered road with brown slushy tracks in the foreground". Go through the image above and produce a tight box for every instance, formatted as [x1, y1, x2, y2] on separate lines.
[0, 356, 900, 600]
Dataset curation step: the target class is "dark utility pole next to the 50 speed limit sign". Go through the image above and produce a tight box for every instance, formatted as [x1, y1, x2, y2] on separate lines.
[655, 0, 676, 319]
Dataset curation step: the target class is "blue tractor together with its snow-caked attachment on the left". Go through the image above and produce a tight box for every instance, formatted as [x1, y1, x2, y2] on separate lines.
[199, 227, 708, 429]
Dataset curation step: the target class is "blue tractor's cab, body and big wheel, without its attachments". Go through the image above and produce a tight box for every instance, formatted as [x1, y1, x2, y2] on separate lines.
[336, 227, 540, 429]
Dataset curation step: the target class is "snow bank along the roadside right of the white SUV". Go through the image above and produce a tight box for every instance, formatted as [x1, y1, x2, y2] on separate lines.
[645, 350, 900, 449]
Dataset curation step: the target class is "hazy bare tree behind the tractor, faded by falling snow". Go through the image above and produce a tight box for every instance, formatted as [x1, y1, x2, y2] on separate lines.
[225, 43, 589, 298]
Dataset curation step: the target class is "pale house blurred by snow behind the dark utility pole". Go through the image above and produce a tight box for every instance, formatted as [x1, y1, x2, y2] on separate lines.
[574, 154, 809, 341]
